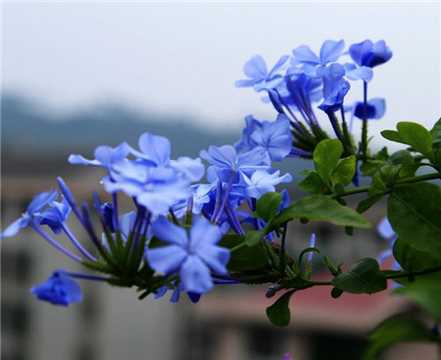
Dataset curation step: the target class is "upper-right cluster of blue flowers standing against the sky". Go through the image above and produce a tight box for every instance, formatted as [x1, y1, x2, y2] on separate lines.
[236, 40, 392, 158]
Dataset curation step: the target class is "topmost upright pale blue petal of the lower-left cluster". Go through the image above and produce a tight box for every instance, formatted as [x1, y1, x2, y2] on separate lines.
[135, 133, 171, 165]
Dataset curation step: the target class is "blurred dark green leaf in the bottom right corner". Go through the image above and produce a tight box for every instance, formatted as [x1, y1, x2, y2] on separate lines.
[363, 315, 436, 360]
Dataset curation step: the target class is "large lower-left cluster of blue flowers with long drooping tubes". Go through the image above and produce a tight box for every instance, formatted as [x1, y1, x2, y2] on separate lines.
[2, 117, 292, 306]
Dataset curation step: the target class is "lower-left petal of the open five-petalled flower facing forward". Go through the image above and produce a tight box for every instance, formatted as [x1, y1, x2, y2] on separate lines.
[146, 245, 188, 274]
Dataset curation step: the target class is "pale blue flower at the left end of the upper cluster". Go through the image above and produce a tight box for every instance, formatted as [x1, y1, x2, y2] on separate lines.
[235, 55, 289, 91]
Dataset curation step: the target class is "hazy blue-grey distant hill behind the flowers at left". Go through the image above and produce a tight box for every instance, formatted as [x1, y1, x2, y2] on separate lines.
[1, 94, 240, 173]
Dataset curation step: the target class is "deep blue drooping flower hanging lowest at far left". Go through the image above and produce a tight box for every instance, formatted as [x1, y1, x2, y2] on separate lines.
[31, 271, 83, 306]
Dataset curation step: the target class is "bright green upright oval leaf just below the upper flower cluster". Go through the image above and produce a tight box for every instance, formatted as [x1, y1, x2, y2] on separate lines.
[313, 139, 343, 182]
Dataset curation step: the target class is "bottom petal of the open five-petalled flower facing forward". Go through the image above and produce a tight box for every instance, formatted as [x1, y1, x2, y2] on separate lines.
[179, 255, 213, 294]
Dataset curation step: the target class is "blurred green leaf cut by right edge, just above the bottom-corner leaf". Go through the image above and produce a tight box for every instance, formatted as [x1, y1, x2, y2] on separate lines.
[394, 273, 441, 321]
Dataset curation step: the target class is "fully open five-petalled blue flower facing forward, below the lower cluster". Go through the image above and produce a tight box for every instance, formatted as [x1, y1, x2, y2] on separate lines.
[146, 217, 230, 294]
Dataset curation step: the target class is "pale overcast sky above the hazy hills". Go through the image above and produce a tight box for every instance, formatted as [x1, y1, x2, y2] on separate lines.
[2, 1, 441, 139]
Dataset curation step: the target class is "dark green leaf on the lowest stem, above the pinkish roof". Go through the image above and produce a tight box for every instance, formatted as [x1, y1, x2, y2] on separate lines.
[332, 258, 387, 294]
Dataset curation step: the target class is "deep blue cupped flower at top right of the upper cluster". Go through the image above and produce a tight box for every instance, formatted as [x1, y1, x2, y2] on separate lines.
[349, 40, 392, 68]
